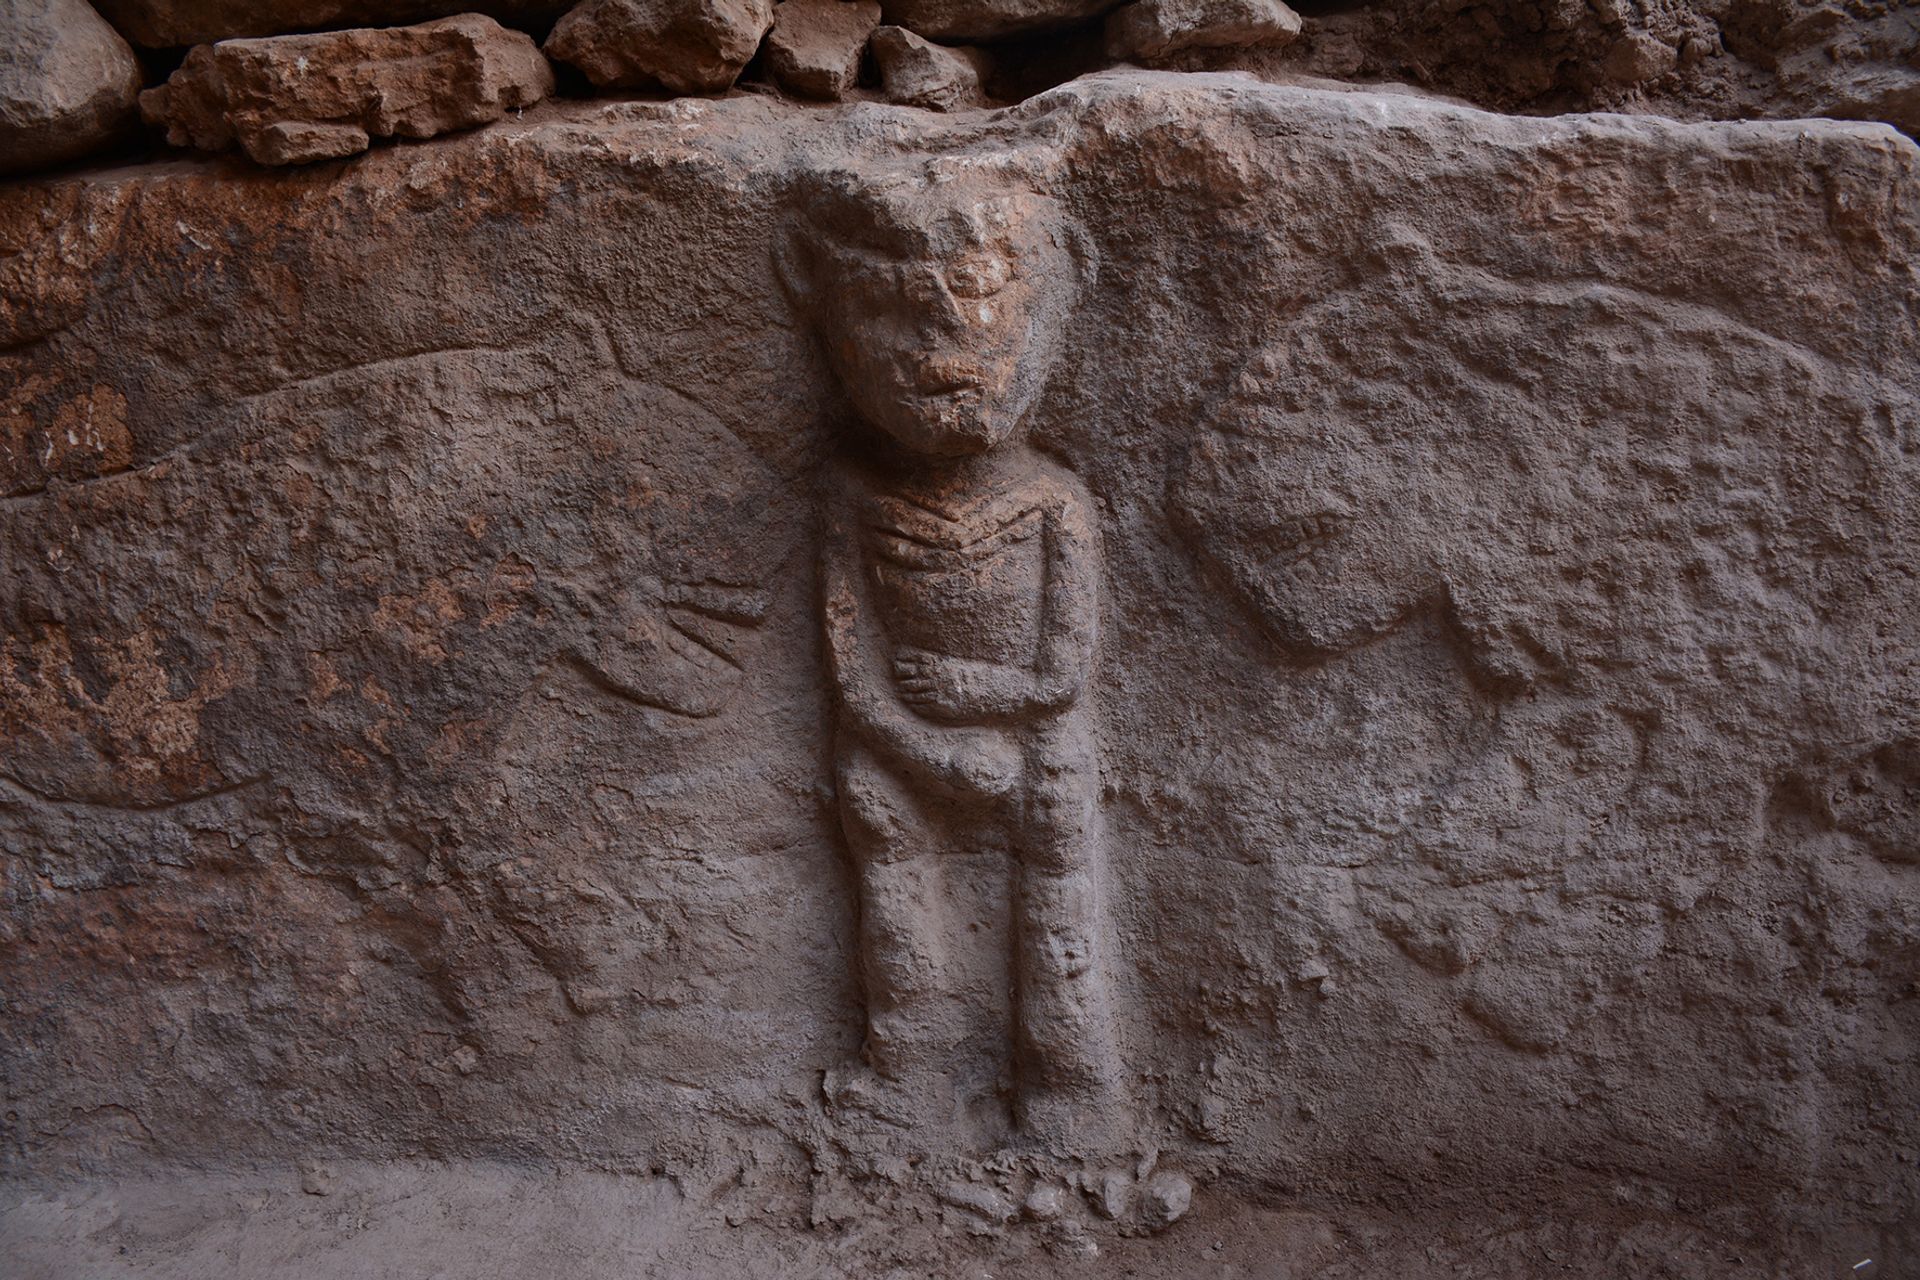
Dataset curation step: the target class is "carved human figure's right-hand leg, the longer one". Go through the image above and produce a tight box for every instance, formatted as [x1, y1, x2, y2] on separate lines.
[1014, 762, 1119, 1132]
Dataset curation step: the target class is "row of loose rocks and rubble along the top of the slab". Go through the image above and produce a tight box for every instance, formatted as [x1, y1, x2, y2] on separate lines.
[0, 0, 1920, 173]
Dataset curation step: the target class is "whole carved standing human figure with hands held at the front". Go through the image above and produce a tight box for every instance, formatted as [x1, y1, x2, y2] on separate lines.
[783, 175, 1114, 1134]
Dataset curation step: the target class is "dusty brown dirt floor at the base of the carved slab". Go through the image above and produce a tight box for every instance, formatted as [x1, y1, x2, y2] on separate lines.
[0, 1163, 1920, 1280]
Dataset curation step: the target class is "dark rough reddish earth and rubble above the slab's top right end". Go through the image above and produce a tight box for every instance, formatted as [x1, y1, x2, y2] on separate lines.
[1259, 0, 1920, 134]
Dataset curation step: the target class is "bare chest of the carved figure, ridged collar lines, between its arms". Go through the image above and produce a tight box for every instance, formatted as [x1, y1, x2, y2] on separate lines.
[858, 478, 1048, 668]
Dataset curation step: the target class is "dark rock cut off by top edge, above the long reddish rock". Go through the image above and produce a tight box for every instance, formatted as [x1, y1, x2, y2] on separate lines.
[100, 0, 566, 48]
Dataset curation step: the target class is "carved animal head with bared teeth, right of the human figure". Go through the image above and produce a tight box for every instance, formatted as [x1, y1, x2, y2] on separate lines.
[1175, 339, 1446, 656]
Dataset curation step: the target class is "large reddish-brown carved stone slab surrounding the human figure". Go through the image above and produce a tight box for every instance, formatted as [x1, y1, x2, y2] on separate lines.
[0, 73, 1920, 1276]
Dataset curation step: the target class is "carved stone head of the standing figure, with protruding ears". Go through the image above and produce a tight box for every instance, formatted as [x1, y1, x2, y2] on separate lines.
[778, 171, 1081, 457]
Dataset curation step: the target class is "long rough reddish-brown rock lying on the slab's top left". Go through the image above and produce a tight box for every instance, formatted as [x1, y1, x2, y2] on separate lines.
[140, 13, 553, 165]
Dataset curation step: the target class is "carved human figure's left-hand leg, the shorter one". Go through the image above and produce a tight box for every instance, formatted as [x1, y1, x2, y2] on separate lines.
[839, 745, 960, 1080]
